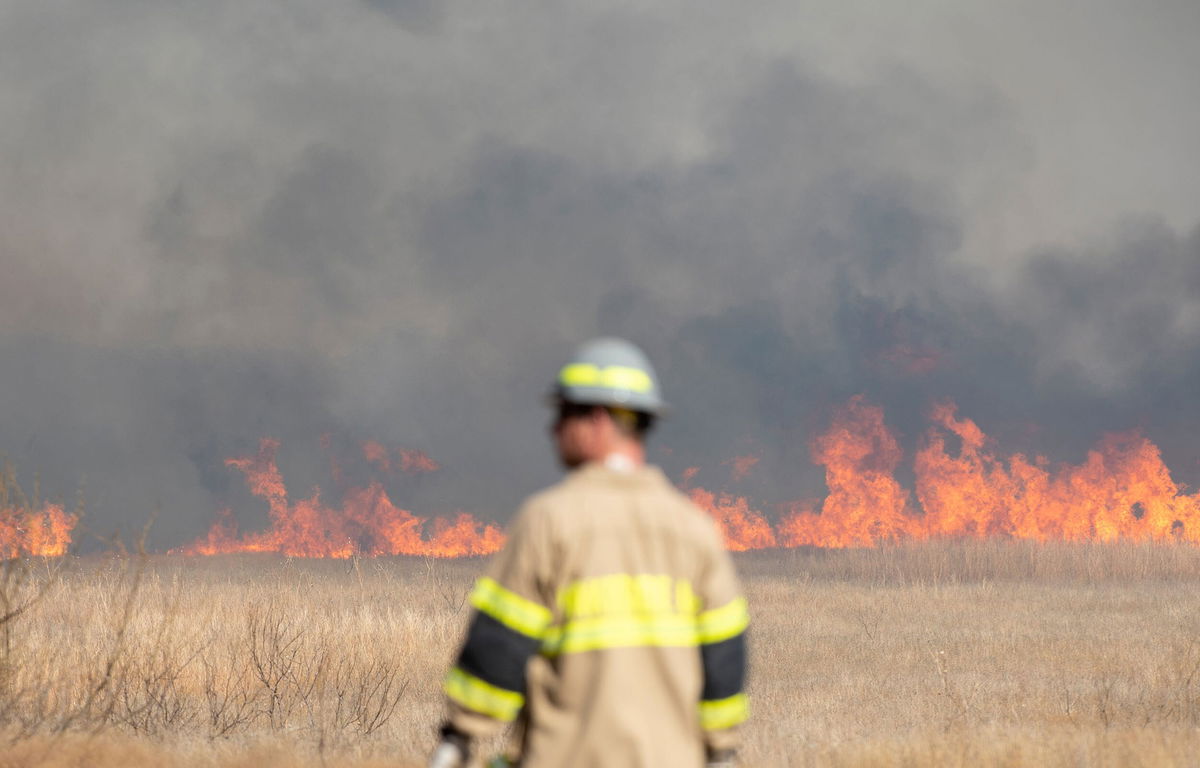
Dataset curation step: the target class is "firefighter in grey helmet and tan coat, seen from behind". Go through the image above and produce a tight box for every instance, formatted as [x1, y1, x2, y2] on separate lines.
[430, 338, 749, 768]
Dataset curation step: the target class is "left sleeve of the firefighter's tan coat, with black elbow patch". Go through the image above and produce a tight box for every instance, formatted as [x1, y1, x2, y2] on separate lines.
[443, 504, 553, 737]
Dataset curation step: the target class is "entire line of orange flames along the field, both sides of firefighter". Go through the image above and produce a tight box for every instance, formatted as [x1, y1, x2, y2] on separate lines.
[182, 396, 1200, 558]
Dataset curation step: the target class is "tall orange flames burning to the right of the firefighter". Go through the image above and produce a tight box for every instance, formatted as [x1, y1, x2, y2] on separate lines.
[689, 396, 1200, 551]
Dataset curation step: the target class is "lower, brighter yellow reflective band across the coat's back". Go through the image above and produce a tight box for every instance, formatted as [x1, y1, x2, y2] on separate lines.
[541, 613, 696, 656]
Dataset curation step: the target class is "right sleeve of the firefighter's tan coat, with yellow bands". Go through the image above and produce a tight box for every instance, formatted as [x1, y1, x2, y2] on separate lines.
[697, 530, 750, 750]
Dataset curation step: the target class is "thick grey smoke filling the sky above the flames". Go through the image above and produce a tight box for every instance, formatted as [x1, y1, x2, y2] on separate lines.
[0, 0, 1200, 546]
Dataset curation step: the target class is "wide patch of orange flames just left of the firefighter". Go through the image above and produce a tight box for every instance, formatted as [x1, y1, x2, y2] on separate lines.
[181, 439, 504, 558]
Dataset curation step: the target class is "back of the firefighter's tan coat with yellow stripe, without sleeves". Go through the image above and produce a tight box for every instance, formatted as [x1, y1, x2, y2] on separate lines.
[522, 464, 738, 768]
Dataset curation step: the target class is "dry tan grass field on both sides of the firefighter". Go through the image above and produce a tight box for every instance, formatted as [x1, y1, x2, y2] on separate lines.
[0, 541, 1200, 768]
